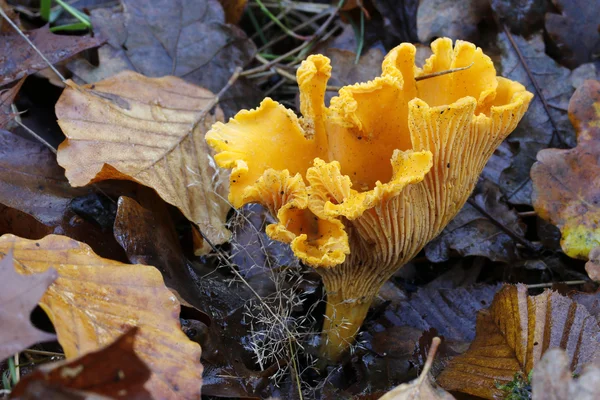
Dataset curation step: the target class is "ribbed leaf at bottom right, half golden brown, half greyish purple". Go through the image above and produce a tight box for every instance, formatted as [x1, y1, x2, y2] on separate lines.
[438, 285, 600, 399]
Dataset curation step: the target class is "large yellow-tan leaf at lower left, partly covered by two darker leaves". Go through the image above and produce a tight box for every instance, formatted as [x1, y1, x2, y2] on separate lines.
[0, 235, 202, 399]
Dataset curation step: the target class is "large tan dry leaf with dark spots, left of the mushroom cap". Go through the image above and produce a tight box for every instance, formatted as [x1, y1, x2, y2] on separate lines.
[56, 71, 230, 248]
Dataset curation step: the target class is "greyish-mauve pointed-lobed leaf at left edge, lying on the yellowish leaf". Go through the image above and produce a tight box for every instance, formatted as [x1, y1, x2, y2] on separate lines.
[0, 252, 58, 361]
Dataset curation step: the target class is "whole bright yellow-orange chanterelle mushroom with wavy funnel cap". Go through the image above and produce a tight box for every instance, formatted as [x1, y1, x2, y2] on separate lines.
[206, 38, 533, 359]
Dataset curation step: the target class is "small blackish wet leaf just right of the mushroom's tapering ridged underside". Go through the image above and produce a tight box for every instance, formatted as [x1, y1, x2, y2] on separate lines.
[425, 180, 525, 263]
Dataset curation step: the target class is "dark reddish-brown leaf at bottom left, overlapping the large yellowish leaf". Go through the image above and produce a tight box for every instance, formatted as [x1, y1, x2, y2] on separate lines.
[10, 328, 153, 400]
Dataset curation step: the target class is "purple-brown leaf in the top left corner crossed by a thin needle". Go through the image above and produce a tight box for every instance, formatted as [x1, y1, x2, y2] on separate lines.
[0, 25, 104, 86]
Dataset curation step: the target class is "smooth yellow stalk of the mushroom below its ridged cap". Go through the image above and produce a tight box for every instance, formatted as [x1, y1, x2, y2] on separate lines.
[319, 290, 372, 362]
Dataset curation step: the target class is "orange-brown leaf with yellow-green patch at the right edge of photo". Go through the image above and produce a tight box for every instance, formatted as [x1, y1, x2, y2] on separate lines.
[531, 80, 600, 259]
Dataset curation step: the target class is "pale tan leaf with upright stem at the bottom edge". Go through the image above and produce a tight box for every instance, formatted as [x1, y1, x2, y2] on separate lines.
[379, 337, 454, 400]
